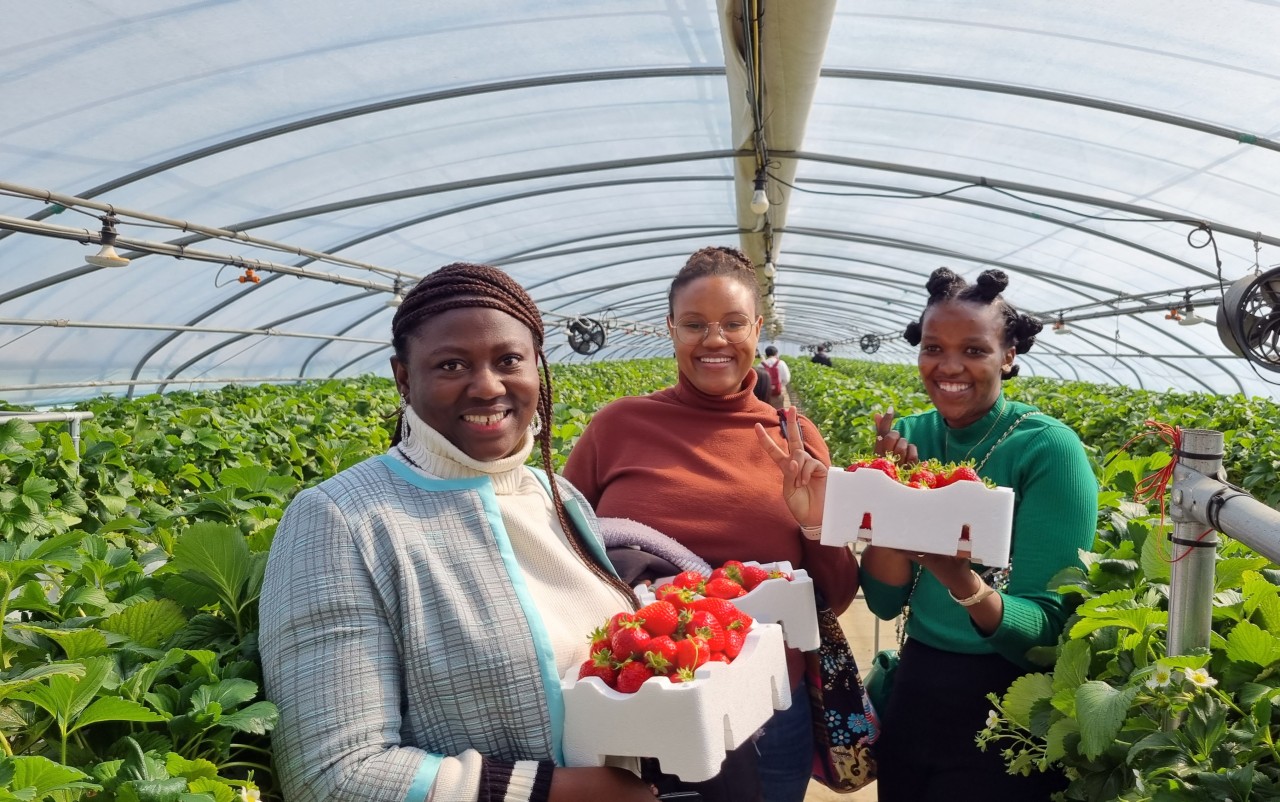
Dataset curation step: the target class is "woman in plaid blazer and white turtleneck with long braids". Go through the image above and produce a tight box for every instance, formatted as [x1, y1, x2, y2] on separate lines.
[260, 263, 654, 802]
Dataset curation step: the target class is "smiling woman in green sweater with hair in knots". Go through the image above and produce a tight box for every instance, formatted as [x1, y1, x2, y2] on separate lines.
[861, 267, 1097, 802]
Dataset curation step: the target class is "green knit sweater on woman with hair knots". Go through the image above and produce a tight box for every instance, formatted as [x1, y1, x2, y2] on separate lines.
[861, 397, 1098, 669]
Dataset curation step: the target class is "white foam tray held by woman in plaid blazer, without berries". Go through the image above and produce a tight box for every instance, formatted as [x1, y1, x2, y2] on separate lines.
[561, 623, 791, 783]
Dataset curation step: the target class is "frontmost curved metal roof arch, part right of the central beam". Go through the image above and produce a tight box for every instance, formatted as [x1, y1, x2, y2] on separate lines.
[820, 68, 1280, 151]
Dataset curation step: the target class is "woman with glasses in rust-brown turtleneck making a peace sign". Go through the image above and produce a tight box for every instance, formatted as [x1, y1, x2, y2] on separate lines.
[564, 248, 858, 802]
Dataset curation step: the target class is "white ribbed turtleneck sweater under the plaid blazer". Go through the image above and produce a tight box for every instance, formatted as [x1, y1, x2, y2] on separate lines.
[389, 407, 631, 802]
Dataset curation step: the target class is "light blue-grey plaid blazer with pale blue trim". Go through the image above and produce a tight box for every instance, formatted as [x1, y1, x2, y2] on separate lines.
[260, 454, 609, 802]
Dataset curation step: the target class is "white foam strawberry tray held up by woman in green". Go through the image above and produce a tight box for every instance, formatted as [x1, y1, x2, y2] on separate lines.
[822, 469, 1014, 568]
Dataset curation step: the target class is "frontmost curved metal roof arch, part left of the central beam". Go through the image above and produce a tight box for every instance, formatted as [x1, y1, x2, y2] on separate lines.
[0, 67, 724, 239]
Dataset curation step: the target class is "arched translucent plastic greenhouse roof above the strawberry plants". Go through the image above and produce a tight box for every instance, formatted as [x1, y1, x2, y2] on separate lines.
[0, 0, 1280, 404]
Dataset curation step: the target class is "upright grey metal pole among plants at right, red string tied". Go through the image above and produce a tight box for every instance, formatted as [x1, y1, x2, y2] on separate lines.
[1169, 429, 1222, 655]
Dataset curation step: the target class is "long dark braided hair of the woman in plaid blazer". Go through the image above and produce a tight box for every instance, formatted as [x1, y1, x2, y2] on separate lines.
[392, 262, 636, 606]
